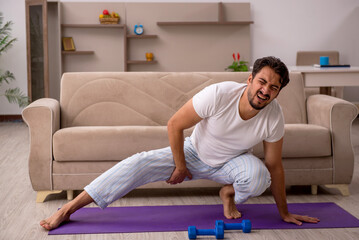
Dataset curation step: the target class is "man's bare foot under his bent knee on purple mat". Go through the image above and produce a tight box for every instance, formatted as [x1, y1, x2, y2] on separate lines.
[219, 185, 242, 219]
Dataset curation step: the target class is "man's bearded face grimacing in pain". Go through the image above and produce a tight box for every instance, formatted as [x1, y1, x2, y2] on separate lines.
[247, 67, 281, 110]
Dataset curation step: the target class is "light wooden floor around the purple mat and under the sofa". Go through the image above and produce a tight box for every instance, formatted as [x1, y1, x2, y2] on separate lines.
[0, 118, 359, 240]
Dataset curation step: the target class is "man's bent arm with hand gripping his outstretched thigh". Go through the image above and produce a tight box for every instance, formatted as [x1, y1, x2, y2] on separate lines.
[167, 99, 202, 184]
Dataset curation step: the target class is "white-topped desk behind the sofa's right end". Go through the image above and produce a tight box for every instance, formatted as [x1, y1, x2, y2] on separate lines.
[288, 66, 359, 95]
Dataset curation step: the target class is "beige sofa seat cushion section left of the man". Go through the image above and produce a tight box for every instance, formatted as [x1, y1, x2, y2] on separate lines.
[53, 126, 192, 161]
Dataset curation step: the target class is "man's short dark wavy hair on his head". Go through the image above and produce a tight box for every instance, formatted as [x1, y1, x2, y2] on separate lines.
[252, 56, 289, 89]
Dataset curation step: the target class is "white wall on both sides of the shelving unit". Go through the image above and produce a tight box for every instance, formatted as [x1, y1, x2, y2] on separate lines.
[0, 0, 359, 115]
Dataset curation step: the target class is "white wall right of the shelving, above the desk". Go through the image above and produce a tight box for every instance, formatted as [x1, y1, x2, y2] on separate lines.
[250, 0, 359, 102]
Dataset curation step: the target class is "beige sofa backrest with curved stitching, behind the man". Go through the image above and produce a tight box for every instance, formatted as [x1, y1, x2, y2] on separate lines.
[60, 72, 306, 128]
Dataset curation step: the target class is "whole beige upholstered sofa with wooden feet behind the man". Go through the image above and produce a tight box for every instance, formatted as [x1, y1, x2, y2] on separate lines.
[22, 72, 357, 202]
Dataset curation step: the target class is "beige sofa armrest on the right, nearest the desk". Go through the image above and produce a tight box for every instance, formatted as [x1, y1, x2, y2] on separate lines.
[307, 95, 358, 184]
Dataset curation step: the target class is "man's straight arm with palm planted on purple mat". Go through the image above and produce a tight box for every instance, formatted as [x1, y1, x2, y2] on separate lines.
[263, 138, 319, 225]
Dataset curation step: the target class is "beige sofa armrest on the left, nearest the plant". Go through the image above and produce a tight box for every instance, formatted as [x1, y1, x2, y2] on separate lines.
[22, 98, 60, 191]
